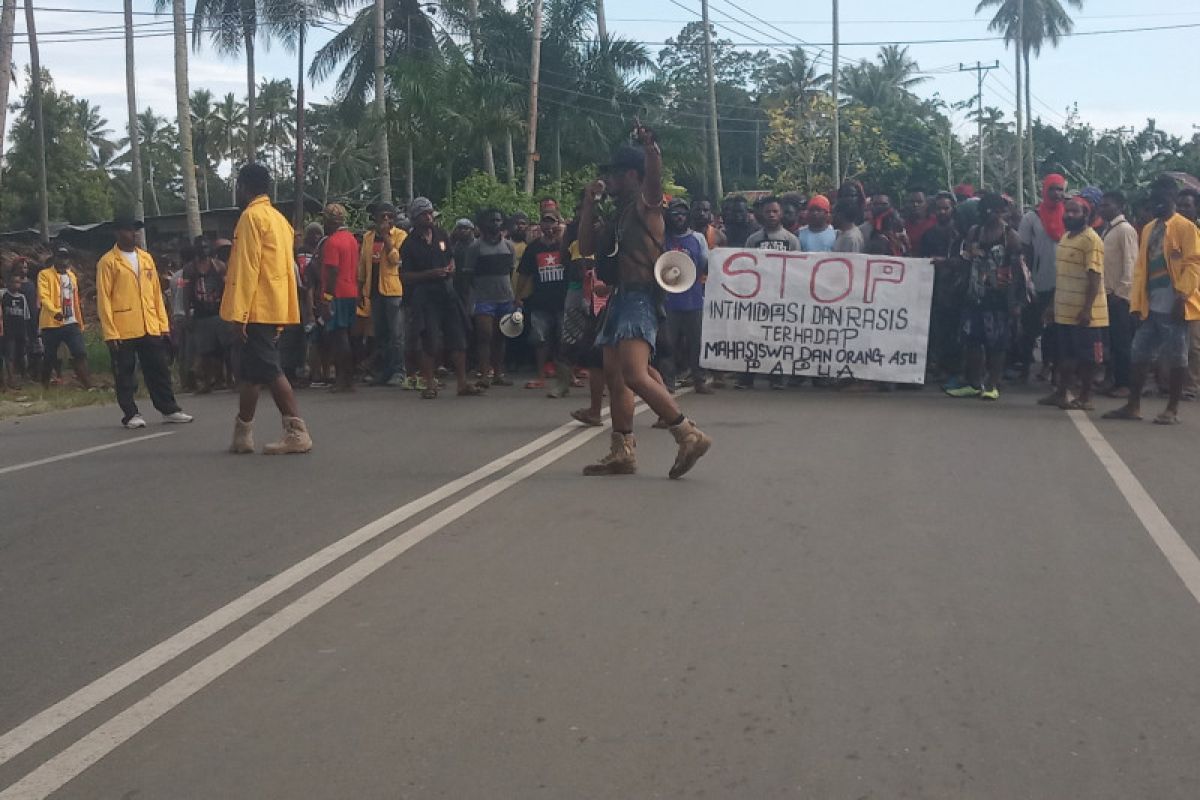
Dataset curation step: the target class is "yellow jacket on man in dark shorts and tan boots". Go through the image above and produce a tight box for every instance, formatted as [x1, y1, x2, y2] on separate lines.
[221, 194, 300, 325]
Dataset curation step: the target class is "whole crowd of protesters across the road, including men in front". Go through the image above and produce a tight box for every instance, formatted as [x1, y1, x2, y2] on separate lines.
[0, 128, 1200, 474]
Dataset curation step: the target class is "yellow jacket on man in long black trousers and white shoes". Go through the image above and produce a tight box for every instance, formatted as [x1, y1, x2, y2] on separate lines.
[96, 245, 170, 342]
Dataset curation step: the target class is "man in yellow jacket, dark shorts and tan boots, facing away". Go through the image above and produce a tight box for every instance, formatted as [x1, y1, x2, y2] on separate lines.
[221, 163, 312, 456]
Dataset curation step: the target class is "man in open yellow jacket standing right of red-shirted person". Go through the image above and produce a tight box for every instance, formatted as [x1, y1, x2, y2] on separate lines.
[359, 205, 408, 386]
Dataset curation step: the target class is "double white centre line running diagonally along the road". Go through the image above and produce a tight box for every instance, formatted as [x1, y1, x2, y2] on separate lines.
[0, 407, 646, 800]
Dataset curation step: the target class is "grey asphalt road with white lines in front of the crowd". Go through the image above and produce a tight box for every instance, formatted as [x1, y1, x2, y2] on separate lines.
[0, 389, 1200, 800]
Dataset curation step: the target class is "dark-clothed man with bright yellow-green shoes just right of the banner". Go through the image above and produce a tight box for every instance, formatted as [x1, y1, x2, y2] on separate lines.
[946, 192, 1031, 401]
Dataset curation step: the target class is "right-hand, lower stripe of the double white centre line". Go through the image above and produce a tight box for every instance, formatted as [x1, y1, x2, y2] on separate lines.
[0, 422, 628, 800]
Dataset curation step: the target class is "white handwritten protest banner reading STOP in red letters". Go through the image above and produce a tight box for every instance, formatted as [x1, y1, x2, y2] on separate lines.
[701, 247, 934, 384]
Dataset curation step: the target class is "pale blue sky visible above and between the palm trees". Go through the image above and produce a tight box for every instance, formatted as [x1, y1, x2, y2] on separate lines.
[13, 0, 1200, 149]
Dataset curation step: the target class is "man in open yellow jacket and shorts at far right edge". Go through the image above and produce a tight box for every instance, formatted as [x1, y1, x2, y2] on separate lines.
[1104, 175, 1200, 425]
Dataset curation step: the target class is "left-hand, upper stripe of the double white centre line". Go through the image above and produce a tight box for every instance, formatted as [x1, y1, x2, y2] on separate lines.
[0, 417, 585, 764]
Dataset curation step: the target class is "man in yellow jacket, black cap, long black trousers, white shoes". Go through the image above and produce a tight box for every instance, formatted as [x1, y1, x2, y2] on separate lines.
[96, 217, 192, 429]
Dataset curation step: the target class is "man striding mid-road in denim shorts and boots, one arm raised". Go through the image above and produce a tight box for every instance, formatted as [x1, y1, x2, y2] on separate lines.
[580, 122, 713, 479]
